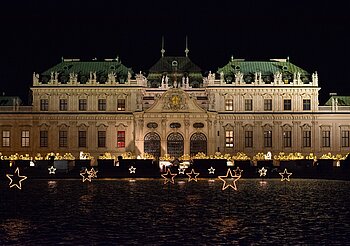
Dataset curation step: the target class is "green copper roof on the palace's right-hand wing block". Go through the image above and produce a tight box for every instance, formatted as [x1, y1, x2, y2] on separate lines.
[218, 59, 309, 76]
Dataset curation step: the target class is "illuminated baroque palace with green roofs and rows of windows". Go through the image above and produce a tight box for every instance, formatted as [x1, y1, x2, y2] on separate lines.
[0, 50, 350, 160]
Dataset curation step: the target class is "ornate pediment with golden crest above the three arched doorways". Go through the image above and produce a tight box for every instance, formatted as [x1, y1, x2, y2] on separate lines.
[145, 88, 206, 113]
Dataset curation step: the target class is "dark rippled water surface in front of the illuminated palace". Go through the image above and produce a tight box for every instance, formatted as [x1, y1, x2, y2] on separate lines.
[0, 179, 350, 245]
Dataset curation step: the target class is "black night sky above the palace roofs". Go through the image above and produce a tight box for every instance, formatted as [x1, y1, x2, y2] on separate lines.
[0, 0, 350, 103]
